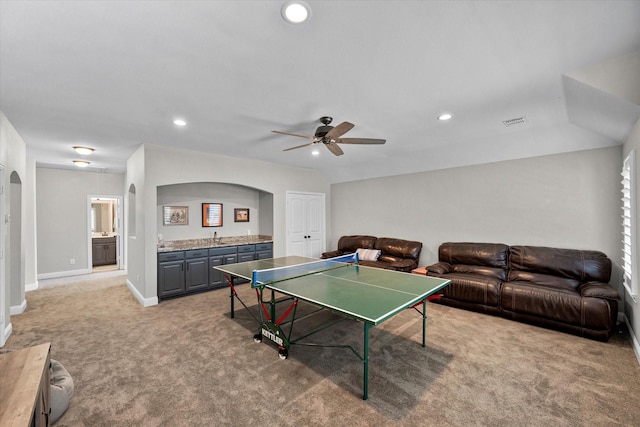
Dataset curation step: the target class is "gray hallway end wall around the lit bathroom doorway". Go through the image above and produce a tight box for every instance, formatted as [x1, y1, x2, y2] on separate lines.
[36, 167, 124, 278]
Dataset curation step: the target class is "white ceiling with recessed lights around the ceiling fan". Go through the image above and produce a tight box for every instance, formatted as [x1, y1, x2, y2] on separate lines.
[0, 0, 640, 183]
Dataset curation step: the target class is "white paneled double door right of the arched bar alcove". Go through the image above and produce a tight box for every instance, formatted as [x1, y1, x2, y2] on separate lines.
[287, 191, 325, 258]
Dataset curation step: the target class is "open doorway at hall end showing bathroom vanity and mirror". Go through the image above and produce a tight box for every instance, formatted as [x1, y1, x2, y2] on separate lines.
[87, 196, 123, 273]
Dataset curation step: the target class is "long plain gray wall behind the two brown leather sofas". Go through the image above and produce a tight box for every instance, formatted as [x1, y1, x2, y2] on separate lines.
[327, 146, 622, 291]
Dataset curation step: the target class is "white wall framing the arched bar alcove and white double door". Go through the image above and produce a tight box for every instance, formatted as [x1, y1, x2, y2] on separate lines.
[125, 144, 330, 305]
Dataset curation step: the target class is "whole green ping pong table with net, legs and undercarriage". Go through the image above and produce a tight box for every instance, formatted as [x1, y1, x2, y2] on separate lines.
[215, 254, 450, 400]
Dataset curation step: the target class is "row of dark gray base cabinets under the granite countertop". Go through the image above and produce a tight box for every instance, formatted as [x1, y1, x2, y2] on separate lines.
[158, 242, 273, 300]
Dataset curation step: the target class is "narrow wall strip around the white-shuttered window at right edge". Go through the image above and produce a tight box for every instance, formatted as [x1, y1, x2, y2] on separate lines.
[622, 120, 640, 361]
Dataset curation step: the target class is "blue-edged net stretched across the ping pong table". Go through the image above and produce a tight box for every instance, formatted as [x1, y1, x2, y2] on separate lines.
[251, 253, 358, 287]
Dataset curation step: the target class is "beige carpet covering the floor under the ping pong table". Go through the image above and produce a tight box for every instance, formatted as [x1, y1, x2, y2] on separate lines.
[3, 274, 640, 426]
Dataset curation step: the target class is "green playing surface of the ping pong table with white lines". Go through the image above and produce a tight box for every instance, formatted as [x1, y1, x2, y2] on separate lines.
[216, 256, 449, 325]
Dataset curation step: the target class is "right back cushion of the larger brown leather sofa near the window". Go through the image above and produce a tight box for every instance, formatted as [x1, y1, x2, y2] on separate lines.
[509, 246, 611, 290]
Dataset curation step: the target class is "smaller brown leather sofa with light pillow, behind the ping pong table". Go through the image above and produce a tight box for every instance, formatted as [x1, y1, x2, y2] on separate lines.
[320, 235, 422, 271]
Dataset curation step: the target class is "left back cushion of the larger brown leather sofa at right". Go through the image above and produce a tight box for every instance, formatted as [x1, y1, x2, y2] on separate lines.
[438, 242, 509, 280]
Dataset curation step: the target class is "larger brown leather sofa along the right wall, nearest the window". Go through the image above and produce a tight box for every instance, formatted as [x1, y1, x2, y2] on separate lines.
[427, 242, 619, 341]
